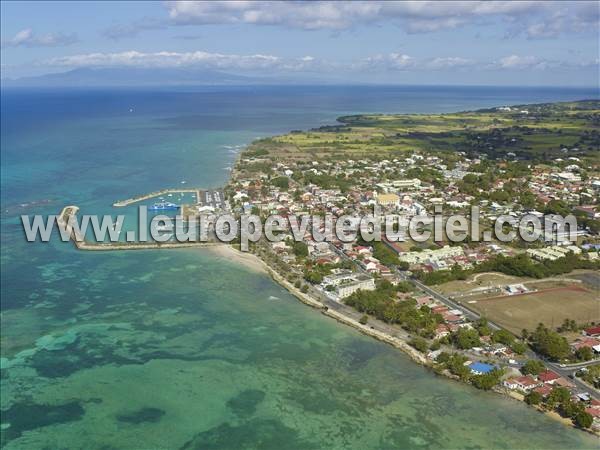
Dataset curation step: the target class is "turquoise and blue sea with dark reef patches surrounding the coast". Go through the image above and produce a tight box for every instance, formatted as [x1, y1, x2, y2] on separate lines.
[1, 86, 599, 449]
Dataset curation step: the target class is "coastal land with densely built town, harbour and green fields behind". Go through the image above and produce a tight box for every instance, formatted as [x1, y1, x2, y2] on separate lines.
[63, 101, 600, 433]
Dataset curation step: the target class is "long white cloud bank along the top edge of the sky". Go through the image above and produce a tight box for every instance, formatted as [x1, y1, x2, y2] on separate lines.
[166, 1, 598, 37]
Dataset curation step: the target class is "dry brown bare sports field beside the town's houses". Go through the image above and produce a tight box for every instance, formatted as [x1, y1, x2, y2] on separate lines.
[468, 284, 600, 334]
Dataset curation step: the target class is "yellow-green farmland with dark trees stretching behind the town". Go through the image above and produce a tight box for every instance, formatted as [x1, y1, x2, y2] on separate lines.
[244, 101, 599, 162]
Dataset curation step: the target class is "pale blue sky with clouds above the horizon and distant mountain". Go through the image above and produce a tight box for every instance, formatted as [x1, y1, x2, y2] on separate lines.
[0, 1, 600, 87]
